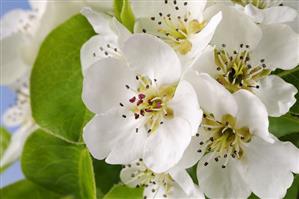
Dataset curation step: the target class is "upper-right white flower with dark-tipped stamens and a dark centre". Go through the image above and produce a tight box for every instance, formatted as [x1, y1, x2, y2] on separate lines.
[194, 7, 299, 116]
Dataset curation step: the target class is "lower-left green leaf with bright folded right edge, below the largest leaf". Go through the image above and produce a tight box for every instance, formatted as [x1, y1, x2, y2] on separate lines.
[21, 130, 96, 199]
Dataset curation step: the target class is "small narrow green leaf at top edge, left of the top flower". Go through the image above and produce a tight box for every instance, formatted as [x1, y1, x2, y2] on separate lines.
[113, 0, 135, 32]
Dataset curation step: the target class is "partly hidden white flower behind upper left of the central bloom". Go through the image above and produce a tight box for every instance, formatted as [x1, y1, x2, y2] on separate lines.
[80, 7, 131, 75]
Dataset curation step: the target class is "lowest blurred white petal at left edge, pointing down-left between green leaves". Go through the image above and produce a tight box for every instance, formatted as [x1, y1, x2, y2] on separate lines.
[0, 121, 37, 168]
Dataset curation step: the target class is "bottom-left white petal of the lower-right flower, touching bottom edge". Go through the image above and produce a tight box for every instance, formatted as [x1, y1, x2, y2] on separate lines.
[197, 154, 251, 199]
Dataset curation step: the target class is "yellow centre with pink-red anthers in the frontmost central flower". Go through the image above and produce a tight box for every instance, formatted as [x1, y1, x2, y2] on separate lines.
[121, 75, 176, 133]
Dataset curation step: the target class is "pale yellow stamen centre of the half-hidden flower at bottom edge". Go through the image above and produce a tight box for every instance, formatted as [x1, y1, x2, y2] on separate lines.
[126, 159, 174, 198]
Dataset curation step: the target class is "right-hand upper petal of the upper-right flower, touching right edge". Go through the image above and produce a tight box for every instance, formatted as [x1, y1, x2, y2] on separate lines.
[251, 24, 299, 70]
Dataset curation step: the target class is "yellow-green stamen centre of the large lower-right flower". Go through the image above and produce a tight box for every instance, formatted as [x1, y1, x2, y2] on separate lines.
[196, 114, 252, 168]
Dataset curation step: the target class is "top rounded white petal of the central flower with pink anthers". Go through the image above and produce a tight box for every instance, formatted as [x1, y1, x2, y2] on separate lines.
[123, 34, 181, 85]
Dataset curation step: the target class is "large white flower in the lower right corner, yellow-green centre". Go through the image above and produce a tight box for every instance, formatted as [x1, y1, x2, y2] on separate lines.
[180, 73, 299, 198]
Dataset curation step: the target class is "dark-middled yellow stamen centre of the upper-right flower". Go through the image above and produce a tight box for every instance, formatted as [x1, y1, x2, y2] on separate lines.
[214, 44, 271, 93]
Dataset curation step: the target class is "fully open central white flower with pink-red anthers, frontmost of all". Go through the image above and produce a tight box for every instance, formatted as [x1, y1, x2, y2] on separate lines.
[82, 34, 202, 172]
